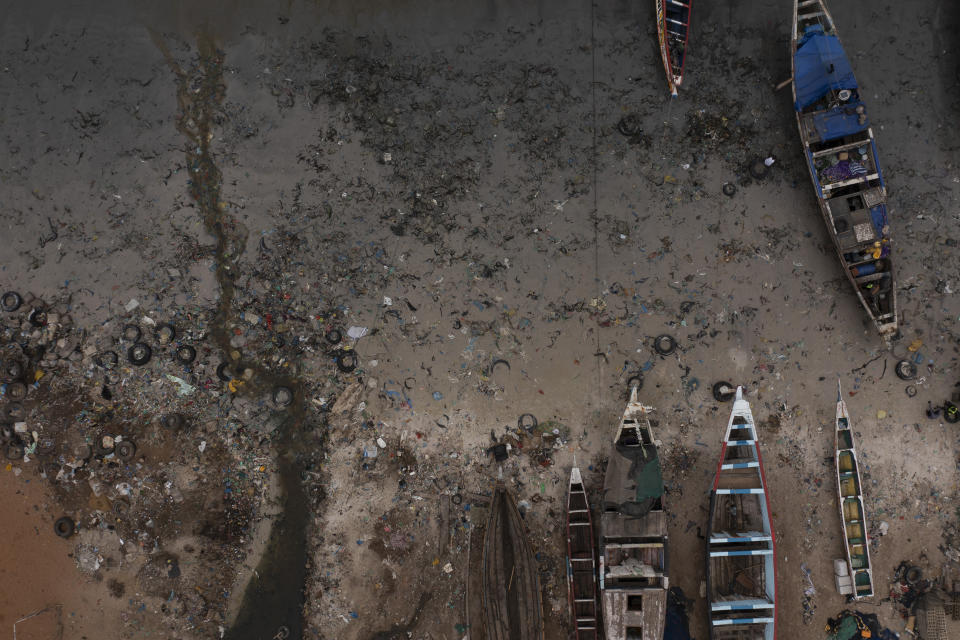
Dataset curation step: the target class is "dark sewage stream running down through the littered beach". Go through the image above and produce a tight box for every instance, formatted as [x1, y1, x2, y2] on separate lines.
[151, 30, 310, 640]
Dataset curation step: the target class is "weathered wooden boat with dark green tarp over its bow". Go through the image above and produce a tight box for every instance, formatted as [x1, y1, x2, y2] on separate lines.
[600, 387, 670, 640]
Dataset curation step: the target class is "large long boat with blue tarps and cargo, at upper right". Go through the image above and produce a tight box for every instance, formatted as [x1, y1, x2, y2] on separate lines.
[791, 0, 897, 338]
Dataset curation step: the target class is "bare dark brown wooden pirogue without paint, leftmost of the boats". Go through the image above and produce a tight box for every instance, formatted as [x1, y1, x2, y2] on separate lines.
[482, 482, 543, 640]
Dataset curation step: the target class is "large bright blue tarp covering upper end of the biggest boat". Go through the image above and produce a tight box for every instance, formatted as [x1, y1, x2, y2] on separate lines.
[793, 25, 857, 111]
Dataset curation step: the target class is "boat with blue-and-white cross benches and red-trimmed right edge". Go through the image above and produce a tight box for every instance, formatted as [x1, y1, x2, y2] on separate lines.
[707, 387, 777, 640]
